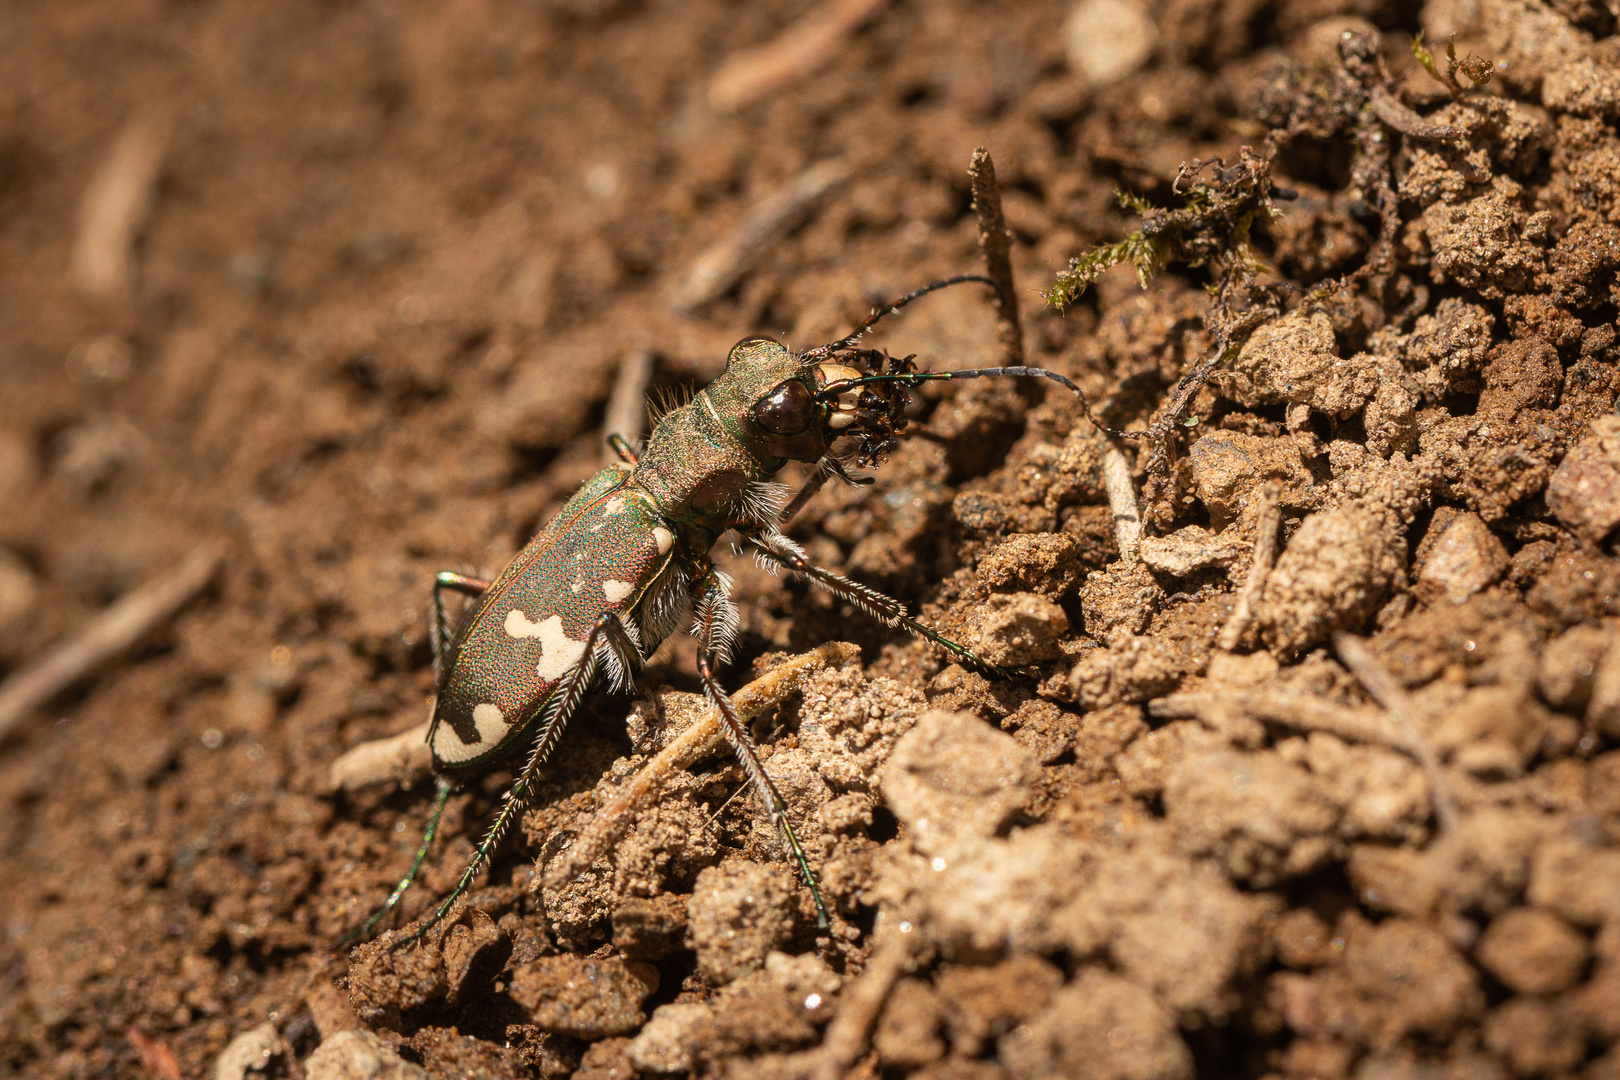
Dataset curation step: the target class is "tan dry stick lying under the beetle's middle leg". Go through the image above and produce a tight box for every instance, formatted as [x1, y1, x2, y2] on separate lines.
[531, 641, 860, 889]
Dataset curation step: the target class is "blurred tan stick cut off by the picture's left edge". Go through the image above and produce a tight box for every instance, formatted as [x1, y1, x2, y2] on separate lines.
[0, 546, 222, 738]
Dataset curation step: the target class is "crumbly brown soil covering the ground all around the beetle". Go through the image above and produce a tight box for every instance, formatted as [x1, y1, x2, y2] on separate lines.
[0, 0, 1620, 1080]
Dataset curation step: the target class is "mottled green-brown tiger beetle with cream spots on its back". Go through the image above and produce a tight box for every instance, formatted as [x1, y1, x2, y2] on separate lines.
[343, 274, 1090, 944]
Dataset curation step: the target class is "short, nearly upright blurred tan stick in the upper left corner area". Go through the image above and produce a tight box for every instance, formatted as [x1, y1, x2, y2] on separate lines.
[73, 117, 168, 298]
